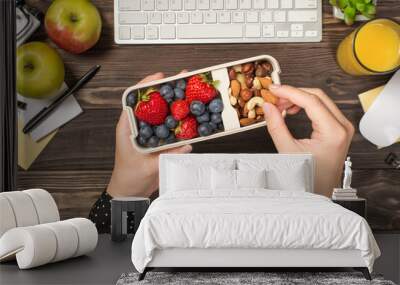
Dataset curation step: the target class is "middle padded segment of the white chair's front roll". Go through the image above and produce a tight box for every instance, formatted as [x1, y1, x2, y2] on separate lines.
[42, 220, 79, 262]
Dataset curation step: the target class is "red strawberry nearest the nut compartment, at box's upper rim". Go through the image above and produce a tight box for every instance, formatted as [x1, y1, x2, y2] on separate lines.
[185, 74, 218, 104]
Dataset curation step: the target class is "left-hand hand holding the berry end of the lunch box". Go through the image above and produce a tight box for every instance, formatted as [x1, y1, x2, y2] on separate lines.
[107, 73, 192, 197]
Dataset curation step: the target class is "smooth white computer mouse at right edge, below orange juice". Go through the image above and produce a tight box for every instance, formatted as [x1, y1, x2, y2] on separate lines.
[360, 70, 400, 147]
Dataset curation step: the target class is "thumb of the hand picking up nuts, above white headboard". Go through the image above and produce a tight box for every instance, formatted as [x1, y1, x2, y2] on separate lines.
[263, 103, 295, 152]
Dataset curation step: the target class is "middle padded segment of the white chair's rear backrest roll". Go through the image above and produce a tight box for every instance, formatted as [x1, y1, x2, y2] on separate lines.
[0, 191, 39, 227]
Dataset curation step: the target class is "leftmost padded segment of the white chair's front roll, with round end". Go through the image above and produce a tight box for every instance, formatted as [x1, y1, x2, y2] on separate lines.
[0, 225, 57, 269]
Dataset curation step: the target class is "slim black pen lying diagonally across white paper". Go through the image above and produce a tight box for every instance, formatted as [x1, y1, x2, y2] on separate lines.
[22, 65, 101, 134]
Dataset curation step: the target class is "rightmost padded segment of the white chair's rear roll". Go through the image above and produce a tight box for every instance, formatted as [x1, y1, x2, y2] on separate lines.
[22, 189, 60, 224]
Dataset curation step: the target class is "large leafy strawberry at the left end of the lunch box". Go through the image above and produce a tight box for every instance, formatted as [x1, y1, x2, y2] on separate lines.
[135, 89, 168, 125]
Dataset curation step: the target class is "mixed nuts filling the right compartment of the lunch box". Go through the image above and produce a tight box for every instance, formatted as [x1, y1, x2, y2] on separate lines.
[228, 61, 278, 127]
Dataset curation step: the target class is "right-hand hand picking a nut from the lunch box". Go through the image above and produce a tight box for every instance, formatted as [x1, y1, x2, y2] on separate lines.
[264, 85, 354, 197]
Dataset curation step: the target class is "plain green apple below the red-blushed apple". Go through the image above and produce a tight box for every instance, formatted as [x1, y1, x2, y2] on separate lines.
[17, 42, 65, 99]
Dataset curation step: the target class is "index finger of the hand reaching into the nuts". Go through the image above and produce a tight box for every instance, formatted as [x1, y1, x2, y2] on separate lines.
[270, 85, 341, 133]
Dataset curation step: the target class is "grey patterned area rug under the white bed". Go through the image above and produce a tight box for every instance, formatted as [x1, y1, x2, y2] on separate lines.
[117, 272, 395, 285]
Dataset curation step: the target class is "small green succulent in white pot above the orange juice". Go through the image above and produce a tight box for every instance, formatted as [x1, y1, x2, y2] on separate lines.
[329, 0, 377, 26]
